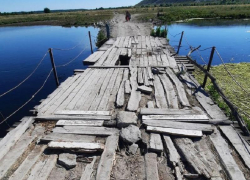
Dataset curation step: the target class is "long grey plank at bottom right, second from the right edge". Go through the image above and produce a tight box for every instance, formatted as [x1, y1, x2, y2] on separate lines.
[209, 131, 245, 180]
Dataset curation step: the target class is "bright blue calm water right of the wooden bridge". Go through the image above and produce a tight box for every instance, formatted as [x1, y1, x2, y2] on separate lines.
[168, 20, 250, 65]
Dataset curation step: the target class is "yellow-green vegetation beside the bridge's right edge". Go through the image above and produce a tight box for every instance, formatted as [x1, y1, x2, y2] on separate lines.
[195, 63, 250, 130]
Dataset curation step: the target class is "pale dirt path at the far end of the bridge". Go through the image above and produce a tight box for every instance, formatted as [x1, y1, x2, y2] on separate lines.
[111, 14, 153, 37]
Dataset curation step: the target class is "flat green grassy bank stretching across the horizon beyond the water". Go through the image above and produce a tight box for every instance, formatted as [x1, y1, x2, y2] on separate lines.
[0, 4, 250, 26]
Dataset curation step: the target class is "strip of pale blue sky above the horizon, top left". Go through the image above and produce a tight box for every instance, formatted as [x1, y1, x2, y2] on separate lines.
[0, 0, 141, 12]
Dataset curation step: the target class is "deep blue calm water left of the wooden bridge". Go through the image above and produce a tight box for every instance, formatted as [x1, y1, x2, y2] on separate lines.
[0, 26, 98, 136]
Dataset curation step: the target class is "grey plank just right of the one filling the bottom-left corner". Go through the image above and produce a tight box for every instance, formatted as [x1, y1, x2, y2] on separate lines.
[10, 145, 46, 180]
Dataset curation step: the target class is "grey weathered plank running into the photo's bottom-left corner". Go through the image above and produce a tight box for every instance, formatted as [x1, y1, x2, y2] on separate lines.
[0, 134, 36, 179]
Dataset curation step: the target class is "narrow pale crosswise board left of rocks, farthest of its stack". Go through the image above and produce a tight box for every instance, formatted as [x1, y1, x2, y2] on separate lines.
[54, 110, 110, 116]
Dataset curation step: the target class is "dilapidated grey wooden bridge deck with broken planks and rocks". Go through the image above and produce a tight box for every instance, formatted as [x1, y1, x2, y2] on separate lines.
[0, 36, 250, 180]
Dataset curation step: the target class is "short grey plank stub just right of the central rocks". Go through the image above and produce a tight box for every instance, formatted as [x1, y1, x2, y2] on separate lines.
[149, 133, 163, 153]
